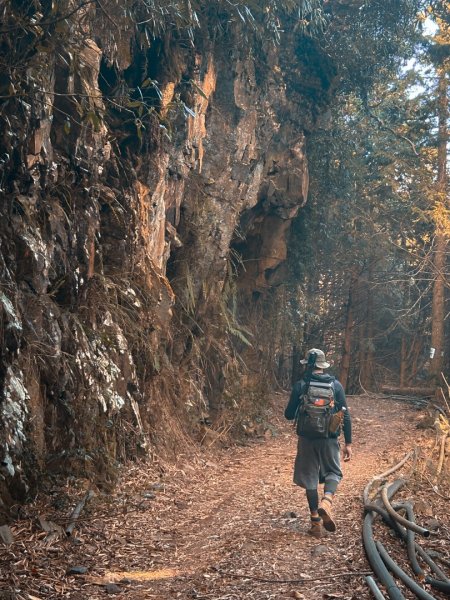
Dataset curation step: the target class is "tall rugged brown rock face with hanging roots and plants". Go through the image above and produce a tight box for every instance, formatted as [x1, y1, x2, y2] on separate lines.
[0, 1, 335, 510]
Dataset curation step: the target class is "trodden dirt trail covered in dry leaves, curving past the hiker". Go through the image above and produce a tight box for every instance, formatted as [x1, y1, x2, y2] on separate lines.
[70, 396, 428, 600]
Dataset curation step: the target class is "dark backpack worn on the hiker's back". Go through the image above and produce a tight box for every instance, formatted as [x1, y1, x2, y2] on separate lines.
[297, 381, 335, 438]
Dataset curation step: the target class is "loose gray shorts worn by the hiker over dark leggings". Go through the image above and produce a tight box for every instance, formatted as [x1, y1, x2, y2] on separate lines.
[294, 437, 342, 490]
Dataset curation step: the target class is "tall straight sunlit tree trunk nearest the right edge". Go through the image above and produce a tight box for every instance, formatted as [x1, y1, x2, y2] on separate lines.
[431, 68, 448, 385]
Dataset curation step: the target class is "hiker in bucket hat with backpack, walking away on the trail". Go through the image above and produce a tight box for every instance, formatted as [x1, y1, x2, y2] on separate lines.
[284, 348, 352, 538]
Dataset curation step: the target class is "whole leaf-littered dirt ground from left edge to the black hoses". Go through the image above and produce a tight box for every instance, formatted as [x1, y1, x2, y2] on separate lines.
[0, 395, 449, 600]
